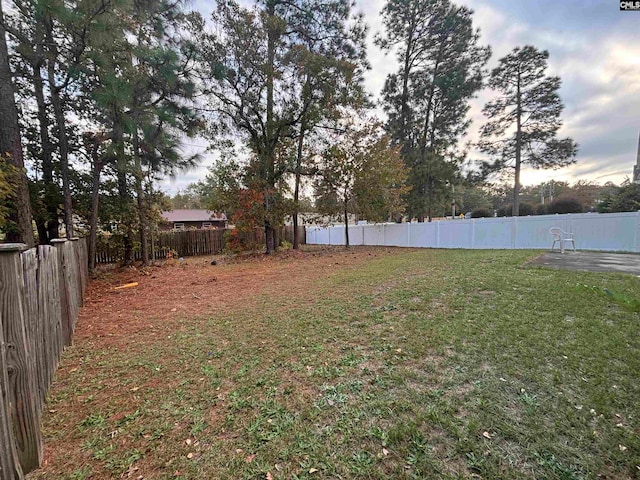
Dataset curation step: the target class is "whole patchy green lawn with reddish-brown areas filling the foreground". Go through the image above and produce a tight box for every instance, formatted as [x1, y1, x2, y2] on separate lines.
[32, 248, 640, 480]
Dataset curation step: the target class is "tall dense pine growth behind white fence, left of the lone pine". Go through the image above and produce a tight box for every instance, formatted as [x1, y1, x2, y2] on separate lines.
[377, 0, 491, 221]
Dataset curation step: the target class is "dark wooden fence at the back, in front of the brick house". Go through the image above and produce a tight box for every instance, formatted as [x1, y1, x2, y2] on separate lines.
[96, 226, 305, 263]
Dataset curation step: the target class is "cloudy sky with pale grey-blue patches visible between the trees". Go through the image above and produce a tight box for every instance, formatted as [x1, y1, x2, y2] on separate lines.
[162, 0, 640, 193]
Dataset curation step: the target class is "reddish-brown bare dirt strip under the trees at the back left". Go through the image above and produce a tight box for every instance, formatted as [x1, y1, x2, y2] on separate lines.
[74, 247, 381, 344]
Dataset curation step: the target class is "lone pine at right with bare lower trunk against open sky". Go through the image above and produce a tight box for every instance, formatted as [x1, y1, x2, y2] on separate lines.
[479, 45, 578, 216]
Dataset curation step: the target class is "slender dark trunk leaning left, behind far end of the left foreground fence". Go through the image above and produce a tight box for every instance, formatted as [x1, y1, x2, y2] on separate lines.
[44, 14, 73, 238]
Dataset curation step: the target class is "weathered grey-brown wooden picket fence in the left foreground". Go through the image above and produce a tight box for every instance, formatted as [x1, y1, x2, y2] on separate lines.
[0, 239, 89, 480]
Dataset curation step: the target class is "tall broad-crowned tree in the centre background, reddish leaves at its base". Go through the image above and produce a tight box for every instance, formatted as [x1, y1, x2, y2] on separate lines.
[195, 0, 362, 253]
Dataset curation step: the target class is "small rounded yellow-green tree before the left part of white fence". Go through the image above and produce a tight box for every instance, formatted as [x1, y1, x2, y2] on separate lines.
[315, 124, 408, 247]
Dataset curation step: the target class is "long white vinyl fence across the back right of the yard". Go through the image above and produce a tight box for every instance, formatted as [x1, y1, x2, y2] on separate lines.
[307, 212, 640, 252]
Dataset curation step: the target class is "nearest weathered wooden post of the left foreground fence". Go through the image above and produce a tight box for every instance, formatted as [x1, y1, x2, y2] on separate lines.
[0, 244, 42, 472]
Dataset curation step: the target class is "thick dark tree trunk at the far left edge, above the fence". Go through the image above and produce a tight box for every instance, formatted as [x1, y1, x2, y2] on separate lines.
[0, 2, 35, 247]
